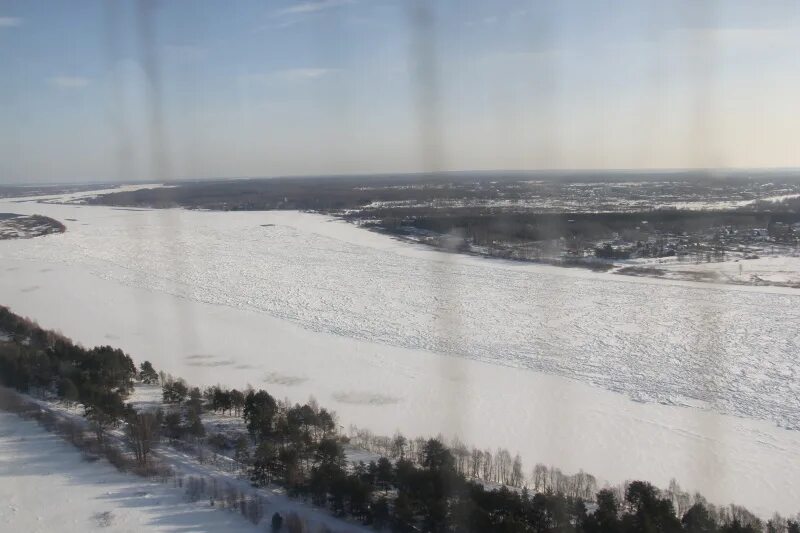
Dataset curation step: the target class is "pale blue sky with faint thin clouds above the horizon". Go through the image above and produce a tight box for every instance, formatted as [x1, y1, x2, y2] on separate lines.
[0, 0, 800, 184]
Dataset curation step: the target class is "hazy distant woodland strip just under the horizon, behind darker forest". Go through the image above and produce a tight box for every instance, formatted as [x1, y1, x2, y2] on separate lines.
[87, 175, 797, 217]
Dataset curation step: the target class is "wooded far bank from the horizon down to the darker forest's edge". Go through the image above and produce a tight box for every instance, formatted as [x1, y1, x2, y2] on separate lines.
[87, 172, 800, 252]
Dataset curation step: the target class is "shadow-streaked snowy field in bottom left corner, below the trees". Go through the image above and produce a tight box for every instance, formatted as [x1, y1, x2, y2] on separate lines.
[0, 412, 263, 533]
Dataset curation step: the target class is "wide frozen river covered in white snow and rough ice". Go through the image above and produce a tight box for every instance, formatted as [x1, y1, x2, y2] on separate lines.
[0, 191, 800, 513]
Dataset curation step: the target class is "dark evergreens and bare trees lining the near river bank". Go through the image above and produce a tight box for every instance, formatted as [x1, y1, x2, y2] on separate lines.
[0, 306, 800, 533]
